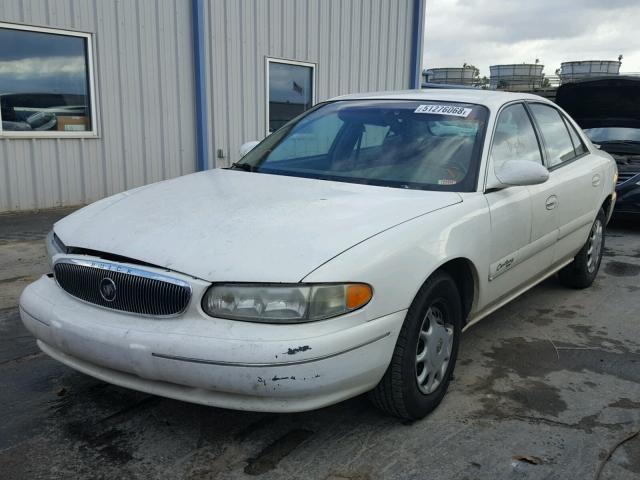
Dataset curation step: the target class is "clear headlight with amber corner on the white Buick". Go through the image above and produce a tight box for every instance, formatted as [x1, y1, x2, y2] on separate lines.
[202, 283, 373, 323]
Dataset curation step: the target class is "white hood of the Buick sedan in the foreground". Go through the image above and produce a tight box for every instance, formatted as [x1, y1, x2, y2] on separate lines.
[55, 169, 462, 282]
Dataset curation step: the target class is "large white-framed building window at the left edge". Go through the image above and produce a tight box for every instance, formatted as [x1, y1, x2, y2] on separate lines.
[0, 23, 96, 137]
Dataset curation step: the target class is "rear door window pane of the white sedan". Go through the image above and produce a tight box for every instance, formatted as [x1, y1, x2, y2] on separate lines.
[530, 103, 576, 167]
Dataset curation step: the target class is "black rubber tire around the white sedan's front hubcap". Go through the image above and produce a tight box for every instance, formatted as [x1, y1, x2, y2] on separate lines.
[369, 272, 462, 420]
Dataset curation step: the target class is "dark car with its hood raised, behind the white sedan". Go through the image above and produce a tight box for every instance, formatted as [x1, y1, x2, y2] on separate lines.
[556, 76, 640, 218]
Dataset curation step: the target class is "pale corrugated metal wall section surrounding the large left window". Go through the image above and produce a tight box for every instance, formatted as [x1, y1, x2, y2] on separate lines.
[0, 0, 195, 211]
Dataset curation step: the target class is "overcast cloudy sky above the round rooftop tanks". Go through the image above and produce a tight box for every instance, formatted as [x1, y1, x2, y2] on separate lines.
[424, 0, 640, 76]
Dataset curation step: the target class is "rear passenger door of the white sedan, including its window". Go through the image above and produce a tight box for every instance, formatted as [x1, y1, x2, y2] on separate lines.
[528, 103, 604, 264]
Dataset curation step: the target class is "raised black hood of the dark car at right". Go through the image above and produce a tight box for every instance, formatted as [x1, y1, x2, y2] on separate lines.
[556, 77, 640, 128]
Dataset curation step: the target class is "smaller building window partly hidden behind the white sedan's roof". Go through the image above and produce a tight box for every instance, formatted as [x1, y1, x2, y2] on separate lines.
[267, 58, 315, 133]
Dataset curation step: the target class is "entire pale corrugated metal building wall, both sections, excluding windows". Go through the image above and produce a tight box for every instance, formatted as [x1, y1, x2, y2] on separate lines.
[0, 0, 414, 211]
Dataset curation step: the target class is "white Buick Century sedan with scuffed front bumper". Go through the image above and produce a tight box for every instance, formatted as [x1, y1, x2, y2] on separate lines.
[20, 90, 617, 419]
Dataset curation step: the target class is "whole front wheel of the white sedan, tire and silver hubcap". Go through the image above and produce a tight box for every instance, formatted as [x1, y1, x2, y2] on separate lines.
[370, 272, 462, 420]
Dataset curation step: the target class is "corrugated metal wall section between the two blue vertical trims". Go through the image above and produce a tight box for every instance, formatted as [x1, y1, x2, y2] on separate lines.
[205, 0, 414, 167]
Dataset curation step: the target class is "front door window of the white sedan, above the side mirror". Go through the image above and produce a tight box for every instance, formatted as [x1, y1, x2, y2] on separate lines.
[491, 103, 542, 171]
